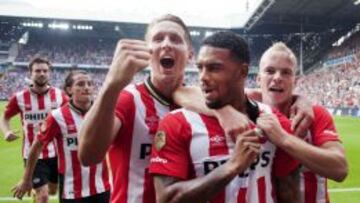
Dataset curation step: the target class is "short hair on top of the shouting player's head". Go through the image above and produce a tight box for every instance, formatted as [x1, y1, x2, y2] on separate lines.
[145, 14, 192, 47]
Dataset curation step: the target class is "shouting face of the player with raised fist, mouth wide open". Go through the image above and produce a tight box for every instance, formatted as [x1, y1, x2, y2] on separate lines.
[147, 21, 191, 82]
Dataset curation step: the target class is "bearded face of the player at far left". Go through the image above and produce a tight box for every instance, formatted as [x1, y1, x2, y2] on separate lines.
[30, 63, 50, 87]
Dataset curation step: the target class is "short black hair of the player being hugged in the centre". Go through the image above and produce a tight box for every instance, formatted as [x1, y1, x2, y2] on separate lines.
[201, 31, 250, 64]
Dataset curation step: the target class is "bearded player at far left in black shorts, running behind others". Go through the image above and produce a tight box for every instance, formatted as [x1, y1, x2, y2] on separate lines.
[0, 57, 68, 202]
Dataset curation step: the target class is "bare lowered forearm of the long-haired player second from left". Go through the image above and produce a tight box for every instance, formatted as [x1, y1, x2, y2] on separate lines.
[23, 140, 42, 182]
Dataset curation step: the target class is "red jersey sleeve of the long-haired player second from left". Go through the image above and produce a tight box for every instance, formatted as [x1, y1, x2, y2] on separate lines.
[37, 113, 61, 146]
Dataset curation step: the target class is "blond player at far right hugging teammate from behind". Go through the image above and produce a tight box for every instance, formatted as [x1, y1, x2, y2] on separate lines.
[257, 43, 348, 203]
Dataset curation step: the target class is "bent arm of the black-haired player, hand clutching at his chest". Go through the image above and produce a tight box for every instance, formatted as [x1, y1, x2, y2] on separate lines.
[154, 130, 261, 203]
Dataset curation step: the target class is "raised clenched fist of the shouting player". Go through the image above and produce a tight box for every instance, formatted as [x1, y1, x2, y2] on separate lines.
[107, 39, 151, 85]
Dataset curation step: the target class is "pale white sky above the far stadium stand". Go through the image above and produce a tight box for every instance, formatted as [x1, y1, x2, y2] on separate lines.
[0, 0, 263, 28]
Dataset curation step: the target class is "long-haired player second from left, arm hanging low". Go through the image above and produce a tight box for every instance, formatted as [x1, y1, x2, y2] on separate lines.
[13, 71, 110, 203]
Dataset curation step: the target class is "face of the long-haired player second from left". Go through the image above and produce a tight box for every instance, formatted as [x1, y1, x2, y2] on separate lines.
[67, 73, 94, 103]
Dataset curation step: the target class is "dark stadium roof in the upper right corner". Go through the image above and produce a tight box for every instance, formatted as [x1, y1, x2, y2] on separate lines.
[245, 0, 360, 33]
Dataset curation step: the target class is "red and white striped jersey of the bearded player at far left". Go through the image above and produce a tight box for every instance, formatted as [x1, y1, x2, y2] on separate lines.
[4, 87, 68, 159]
